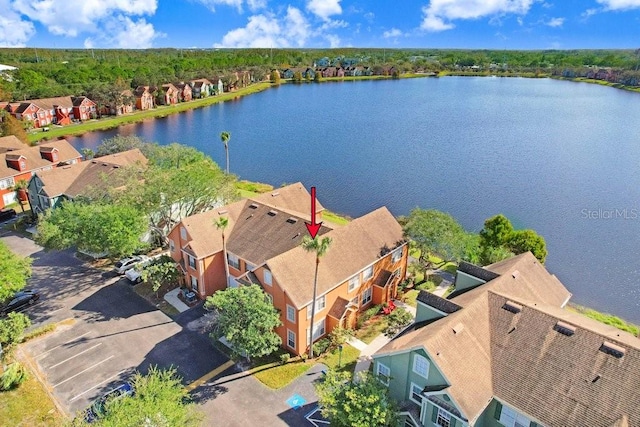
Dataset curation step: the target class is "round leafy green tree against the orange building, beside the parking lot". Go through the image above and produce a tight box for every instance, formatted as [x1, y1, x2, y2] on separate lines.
[205, 285, 282, 360]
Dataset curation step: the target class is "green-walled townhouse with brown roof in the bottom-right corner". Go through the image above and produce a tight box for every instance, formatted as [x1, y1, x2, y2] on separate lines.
[372, 253, 640, 427]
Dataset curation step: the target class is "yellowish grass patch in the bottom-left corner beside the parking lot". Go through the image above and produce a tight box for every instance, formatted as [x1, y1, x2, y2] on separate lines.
[0, 364, 65, 427]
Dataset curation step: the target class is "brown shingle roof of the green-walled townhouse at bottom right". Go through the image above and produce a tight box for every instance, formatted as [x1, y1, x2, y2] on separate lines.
[378, 254, 640, 427]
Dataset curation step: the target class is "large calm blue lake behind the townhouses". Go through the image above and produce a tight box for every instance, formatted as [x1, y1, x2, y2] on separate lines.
[69, 77, 640, 323]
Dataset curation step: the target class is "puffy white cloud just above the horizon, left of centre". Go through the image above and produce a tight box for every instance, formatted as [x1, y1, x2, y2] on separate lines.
[214, 6, 310, 48]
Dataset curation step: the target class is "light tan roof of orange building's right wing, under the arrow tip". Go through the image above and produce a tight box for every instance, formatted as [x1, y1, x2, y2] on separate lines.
[267, 207, 403, 308]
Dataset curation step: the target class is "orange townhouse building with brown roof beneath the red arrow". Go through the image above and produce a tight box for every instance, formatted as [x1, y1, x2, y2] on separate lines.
[169, 183, 408, 355]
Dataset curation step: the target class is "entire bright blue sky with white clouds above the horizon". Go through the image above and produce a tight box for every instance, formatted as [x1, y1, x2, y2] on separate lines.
[0, 0, 640, 49]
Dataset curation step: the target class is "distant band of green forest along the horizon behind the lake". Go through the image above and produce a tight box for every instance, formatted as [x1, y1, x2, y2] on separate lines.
[0, 48, 640, 101]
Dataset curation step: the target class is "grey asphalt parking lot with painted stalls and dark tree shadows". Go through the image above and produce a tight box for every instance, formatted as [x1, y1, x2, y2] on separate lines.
[2, 233, 226, 414]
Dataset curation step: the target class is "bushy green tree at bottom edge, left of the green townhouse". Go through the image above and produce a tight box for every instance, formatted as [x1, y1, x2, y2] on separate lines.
[316, 371, 397, 427]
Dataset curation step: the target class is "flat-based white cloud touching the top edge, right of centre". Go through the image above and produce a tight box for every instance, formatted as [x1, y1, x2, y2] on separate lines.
[420, 0, 536, 31]
